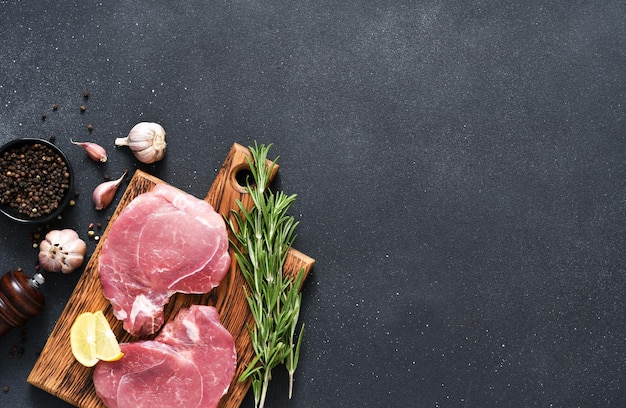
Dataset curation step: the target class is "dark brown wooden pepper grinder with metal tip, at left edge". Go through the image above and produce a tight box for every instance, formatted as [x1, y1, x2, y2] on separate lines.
[0, 269, 45, 337]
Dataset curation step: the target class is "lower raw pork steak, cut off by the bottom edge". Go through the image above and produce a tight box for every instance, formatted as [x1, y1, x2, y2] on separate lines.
[93, 305, 237, 408]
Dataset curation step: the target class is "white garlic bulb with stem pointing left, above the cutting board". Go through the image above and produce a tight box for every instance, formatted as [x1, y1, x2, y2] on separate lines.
[115, 122, 166, 164]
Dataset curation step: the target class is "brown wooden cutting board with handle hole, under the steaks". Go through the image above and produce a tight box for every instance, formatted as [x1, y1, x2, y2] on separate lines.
[27, 144, 315, 408]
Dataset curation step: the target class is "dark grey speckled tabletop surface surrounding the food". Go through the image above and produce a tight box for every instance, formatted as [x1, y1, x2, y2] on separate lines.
[0, 0, 626, 408]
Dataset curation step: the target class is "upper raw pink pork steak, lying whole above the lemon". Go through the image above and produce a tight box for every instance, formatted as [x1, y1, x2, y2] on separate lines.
[100, 184, 230, 336]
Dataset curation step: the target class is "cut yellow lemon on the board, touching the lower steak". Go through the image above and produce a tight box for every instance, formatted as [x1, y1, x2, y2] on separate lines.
[70, 311, 124, 367]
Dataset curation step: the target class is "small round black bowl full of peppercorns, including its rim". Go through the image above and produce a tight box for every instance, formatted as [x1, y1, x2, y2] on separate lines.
[0, 138, 74, 224]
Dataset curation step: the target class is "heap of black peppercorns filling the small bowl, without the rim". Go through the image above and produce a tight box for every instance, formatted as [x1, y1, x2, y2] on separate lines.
[0, 143, 70, 218]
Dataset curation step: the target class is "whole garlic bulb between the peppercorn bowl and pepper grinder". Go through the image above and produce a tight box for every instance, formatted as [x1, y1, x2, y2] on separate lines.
[39, 229, 87, 273]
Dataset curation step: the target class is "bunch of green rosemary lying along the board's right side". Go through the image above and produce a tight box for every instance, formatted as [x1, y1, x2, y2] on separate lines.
[229, 142, 304, 408]
